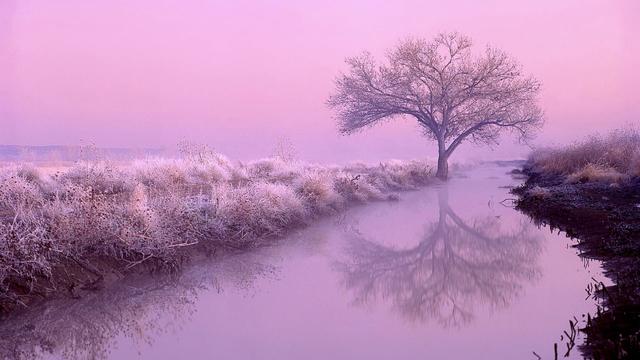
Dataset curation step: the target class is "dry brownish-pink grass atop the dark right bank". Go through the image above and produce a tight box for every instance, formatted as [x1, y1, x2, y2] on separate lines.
[529, 128, 640, 183]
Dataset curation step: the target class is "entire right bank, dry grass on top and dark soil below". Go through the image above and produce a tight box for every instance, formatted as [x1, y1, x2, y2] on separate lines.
[514, 130, 640, 359]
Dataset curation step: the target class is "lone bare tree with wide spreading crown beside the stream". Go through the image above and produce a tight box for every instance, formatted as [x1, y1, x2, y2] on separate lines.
[327, 33, 543, 179]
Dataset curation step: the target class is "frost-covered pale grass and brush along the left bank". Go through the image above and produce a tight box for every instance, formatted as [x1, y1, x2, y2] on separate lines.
[0, 153, 432, 303]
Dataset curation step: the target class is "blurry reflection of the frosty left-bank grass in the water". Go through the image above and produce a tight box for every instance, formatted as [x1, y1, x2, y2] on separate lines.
[0, 254, 276, 359]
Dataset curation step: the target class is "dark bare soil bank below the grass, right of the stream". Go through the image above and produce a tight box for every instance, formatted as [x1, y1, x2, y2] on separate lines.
[513, 166, 640, 359]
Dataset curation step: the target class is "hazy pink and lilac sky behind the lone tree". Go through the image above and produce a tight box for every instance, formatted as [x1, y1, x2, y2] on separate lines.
[0, 0, 640, 161]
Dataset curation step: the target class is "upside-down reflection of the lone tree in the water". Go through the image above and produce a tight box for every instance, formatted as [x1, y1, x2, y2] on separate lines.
[337, 187, 541, 326]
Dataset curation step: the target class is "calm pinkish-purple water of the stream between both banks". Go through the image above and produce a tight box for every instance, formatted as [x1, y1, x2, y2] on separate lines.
[0, 164, 605, 359]
